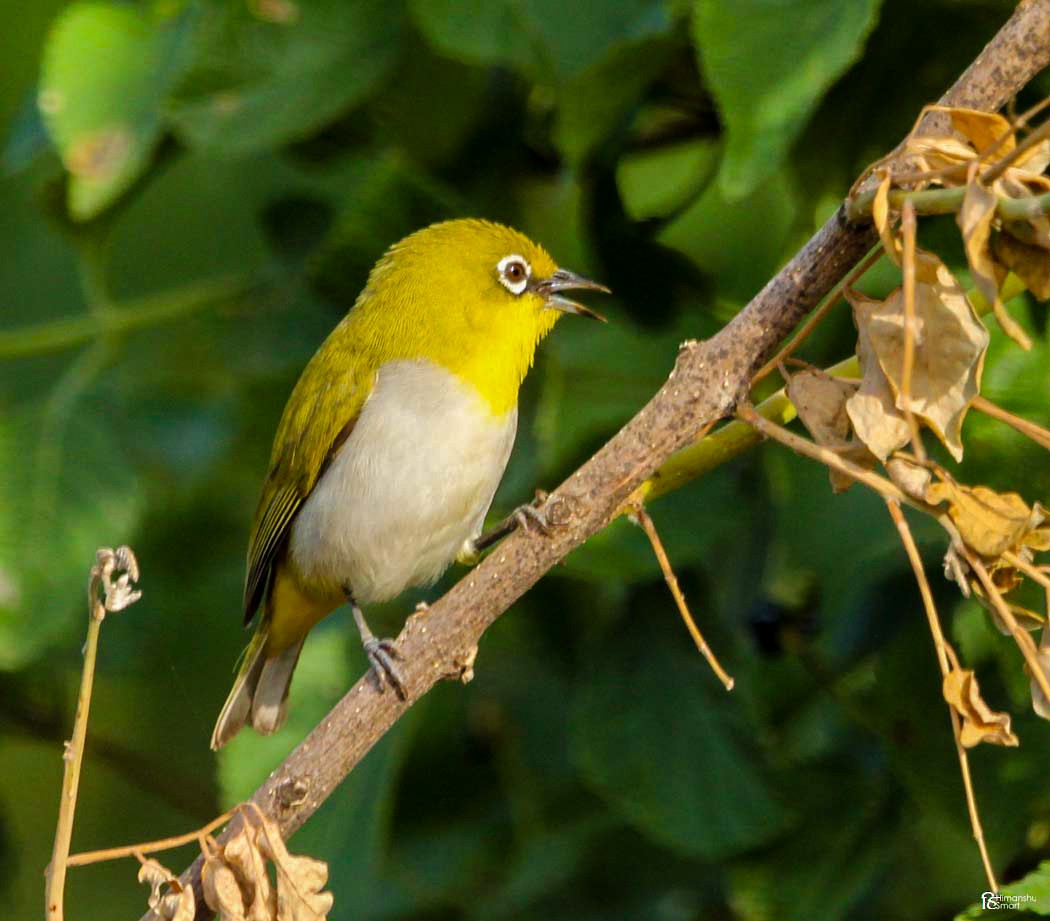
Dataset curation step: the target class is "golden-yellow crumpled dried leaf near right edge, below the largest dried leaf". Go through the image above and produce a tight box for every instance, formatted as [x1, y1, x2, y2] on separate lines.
[926, 480, 1032, 559]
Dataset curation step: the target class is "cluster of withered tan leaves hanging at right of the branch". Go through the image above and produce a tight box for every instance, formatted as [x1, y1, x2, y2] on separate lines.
[786, 107, 1050, 748]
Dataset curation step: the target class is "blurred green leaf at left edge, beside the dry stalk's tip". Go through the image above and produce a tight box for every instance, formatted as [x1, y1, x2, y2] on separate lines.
[0, 400, 143, 670]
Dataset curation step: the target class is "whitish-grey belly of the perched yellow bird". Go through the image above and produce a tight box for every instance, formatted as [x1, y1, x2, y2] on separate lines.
[289, 361, 518, 604]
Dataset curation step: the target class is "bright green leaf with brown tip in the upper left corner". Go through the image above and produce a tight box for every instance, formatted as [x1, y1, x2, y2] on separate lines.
[37, 0, 182, 221]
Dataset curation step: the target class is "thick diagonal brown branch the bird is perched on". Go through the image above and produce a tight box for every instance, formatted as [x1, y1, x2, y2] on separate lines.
[146, 0, 1050, 921]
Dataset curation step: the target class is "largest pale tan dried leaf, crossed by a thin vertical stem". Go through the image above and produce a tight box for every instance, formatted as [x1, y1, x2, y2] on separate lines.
[846, 251, 989, 460]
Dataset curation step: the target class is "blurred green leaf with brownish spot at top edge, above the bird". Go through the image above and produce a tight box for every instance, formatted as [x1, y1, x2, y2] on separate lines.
[166, 0, 401, 155]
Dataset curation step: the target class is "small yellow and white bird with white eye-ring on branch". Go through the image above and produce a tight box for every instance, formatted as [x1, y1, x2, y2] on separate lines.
[211, 219, 608, 749]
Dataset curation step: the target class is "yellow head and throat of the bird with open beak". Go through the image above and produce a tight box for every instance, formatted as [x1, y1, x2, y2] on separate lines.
[348, 219, 608, 413]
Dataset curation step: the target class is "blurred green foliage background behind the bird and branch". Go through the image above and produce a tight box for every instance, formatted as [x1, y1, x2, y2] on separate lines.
[0, 0, 1050, 921]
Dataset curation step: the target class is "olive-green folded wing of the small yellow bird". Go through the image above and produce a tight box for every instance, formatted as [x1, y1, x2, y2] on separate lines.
[245, 320, 375, 624]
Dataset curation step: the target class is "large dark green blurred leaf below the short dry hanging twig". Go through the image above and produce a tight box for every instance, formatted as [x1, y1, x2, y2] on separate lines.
[571, 600, 788, 860]
